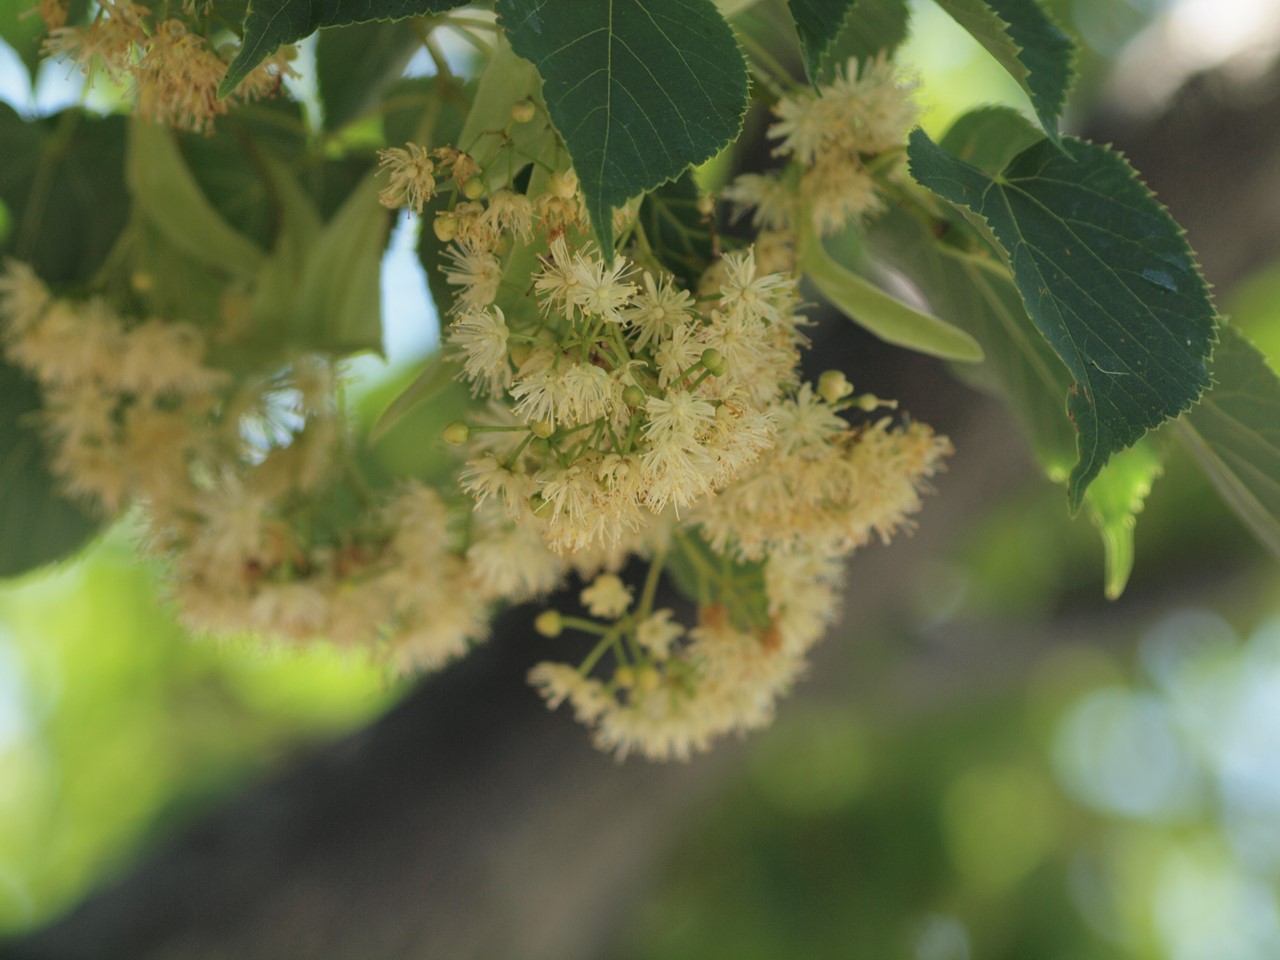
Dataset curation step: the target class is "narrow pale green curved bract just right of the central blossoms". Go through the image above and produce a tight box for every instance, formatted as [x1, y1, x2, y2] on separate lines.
[796, 215, 982, 362]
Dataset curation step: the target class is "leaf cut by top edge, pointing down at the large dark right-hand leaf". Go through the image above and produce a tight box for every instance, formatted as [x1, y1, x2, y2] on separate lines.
[937, 0, 1075, 142]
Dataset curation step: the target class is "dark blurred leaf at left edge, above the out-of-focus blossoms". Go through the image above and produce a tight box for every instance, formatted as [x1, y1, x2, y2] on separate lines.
[0, 102, 129, 283]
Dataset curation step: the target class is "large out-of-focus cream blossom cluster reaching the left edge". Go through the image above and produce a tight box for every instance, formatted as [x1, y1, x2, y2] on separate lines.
[0, 262, 499, 668]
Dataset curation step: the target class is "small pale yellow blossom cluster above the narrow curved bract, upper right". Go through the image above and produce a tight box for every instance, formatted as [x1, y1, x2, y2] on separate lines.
[724, 56, 918, 236]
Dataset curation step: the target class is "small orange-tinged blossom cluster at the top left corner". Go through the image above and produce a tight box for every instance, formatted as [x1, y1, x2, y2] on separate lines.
[38, 0, 293, 132]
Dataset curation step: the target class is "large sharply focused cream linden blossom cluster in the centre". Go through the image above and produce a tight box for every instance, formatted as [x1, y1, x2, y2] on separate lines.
[409, 140, 950, 759]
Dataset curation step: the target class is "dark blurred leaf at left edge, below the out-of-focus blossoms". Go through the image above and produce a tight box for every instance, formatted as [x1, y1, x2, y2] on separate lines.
[0, 361, 101, 577]
